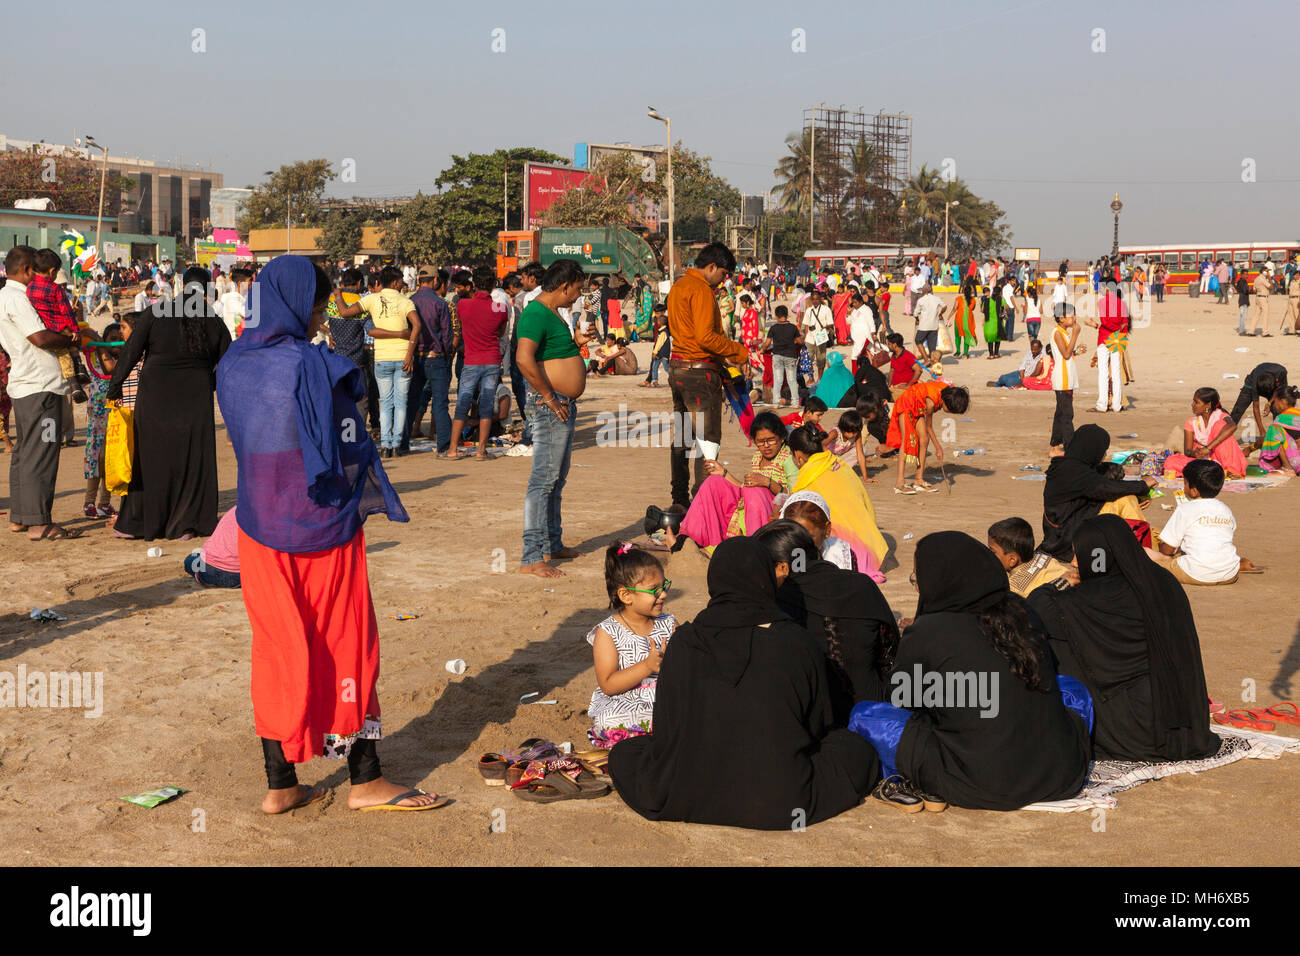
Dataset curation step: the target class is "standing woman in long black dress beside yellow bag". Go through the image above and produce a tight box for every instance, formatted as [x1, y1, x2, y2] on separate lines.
[107, 268, 231, 540]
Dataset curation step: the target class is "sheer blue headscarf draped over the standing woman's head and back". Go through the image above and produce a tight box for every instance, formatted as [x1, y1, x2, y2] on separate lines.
[217, 255, 410, 553]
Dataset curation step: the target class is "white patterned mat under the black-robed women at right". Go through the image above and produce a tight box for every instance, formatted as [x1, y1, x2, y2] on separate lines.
[1022, 724, 1300, 813]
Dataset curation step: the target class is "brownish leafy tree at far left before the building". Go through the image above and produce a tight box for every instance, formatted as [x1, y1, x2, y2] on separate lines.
[0, 147, 135, 216]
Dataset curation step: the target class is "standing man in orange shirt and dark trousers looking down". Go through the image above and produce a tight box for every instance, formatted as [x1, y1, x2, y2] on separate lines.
[668, 242, 749, 510]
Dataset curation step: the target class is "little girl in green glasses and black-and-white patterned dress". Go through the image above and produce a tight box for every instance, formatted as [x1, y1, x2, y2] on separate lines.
[586, 544, 677, 748]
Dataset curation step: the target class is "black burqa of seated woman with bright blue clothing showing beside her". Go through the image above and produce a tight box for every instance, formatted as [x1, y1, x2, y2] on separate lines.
[891, 531, 1088, 810]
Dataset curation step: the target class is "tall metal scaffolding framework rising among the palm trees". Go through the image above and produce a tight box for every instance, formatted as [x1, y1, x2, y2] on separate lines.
[803, 107, 911, 245]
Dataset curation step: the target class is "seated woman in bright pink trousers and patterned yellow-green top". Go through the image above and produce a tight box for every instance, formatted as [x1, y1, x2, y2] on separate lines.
[667, 411, 798, 550]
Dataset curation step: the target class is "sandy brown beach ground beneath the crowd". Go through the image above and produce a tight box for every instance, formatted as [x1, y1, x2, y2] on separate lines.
[0, 297, 1300, 866]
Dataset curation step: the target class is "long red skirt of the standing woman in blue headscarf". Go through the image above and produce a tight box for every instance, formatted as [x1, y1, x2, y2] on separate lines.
[239, 531, 380, 763]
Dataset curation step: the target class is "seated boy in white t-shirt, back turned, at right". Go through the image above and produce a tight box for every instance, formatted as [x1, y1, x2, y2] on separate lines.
[1160, 458, 1257, 584]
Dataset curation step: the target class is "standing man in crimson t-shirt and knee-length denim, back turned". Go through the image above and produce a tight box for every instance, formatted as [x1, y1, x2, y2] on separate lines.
[447, 265, 510, 462]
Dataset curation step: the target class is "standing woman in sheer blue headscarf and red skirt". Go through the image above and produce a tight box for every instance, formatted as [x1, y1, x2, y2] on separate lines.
[217, 255, 447, 813]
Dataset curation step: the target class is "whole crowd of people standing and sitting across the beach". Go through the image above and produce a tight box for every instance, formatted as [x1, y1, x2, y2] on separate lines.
[0, 234, 1300, 829]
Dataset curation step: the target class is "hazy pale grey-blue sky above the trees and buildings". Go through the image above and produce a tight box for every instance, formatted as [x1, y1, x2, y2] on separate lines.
[0, 0, 1300, 256]
